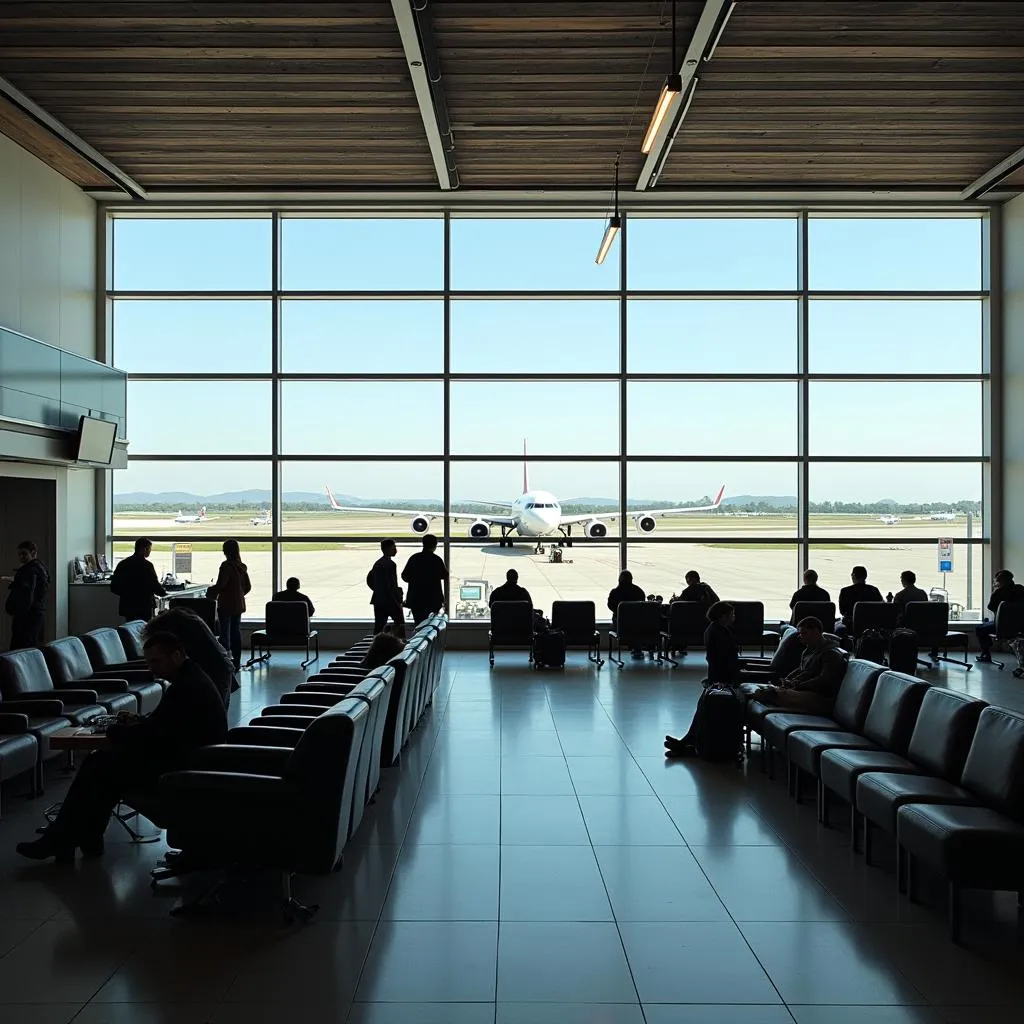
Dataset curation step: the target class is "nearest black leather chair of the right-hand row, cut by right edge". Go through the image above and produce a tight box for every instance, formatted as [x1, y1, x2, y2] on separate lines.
[896, 708, 1024, 942]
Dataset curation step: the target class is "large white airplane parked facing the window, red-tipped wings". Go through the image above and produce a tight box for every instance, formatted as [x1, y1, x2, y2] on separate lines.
[327, 444, 725, 549]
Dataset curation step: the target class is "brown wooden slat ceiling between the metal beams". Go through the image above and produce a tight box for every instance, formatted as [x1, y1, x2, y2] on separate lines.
[0, 0, 1024, 191]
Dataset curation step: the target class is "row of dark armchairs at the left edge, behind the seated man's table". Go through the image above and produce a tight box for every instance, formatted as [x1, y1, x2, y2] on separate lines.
[0, 622, 163, 796]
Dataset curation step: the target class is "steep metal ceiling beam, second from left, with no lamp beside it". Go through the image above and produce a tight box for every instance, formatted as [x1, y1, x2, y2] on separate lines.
[391, 0, 459, 191]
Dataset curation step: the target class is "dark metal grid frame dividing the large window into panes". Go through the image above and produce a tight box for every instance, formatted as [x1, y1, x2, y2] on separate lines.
[103, 204, 1002, 614]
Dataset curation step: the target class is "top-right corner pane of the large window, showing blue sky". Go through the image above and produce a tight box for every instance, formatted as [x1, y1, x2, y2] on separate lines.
[808, 217, 981, 292]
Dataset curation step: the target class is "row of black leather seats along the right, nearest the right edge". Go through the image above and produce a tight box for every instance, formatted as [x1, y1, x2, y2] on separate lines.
[746, 658, 1024, 941]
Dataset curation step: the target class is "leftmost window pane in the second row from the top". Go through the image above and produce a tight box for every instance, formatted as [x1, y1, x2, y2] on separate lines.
[112, 299, 271, 374]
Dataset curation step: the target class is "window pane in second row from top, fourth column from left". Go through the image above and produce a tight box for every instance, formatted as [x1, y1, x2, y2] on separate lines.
[627, 299, 798, 374]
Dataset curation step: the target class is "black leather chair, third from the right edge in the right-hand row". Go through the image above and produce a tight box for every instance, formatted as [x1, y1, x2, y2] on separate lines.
[785, 672, 928, 824]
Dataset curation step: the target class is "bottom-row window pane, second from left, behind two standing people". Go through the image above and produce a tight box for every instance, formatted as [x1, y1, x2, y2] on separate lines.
[280, 541, 422, 618]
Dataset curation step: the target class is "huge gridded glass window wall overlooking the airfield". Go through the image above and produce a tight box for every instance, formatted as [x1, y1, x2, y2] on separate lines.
[105, 211, 993, 620]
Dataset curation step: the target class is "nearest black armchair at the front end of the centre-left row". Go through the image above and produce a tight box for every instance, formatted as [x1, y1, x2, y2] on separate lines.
[160, 698, 370, 919]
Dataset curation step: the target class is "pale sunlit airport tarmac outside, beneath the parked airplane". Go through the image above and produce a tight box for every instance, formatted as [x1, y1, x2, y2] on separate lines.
[115, 513, 988, 618]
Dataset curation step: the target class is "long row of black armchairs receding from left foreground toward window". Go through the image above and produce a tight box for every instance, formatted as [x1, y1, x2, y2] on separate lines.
[148, 614, 447, 919]
